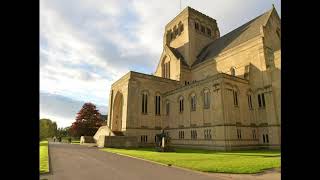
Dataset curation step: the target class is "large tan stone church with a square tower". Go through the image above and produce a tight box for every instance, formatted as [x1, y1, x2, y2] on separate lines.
[94, 7, 281, 150]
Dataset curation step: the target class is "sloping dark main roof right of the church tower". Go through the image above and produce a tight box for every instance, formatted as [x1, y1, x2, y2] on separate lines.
[192, 7, 274, 66]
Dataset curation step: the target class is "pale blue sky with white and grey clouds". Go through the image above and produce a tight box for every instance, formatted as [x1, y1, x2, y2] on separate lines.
[40, 0, 281, 127]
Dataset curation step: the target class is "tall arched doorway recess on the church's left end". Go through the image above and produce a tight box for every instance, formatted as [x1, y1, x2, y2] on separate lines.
[111, 92, 123, 131]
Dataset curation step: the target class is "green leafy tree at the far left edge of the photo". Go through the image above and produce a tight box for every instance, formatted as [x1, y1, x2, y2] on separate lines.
[39, 119, 57, 140]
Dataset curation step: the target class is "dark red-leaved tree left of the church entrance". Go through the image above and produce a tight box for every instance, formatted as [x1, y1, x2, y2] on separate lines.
[70, 103, 103, 137]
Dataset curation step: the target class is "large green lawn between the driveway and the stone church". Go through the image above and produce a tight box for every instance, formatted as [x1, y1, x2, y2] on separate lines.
[102, 148, 281, 174]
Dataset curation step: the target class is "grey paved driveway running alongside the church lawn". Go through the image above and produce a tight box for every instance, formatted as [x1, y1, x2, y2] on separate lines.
[40, 143, 280, 180]
